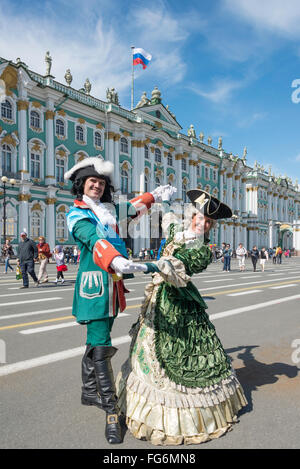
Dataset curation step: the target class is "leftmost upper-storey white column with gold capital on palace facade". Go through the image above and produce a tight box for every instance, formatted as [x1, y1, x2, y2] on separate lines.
[17, 100, 30, 180]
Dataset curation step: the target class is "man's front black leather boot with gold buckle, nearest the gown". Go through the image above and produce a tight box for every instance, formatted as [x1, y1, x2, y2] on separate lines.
[93, 346, 122, 444]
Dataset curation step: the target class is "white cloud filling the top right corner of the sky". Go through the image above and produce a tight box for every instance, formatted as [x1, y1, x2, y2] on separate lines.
[223, 0, 300, 38]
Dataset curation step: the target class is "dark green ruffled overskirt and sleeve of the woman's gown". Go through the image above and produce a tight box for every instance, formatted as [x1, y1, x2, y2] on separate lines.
[154, 227, 232, 388]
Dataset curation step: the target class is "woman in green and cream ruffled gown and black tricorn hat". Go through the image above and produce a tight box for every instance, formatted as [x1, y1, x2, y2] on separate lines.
[117, 190, 247, 445]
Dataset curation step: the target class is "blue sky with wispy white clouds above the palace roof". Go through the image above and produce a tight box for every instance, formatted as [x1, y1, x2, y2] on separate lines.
[0, 0, 300, 181]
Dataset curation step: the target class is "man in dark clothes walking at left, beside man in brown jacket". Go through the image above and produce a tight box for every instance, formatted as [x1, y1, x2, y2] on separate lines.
[17, 231, 39, 288]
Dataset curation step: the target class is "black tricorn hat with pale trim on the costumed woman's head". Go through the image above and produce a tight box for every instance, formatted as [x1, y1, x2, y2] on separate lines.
[187, 189, 232, 220]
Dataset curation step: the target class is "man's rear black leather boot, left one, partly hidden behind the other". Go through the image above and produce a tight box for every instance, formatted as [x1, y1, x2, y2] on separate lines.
[81, 345, 103, 409]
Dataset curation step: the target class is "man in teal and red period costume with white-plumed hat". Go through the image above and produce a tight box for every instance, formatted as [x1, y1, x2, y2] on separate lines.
[65, 157, 170, 444]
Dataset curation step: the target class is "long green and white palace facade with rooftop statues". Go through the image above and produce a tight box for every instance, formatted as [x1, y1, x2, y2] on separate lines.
[0, 53, 300, 255]
